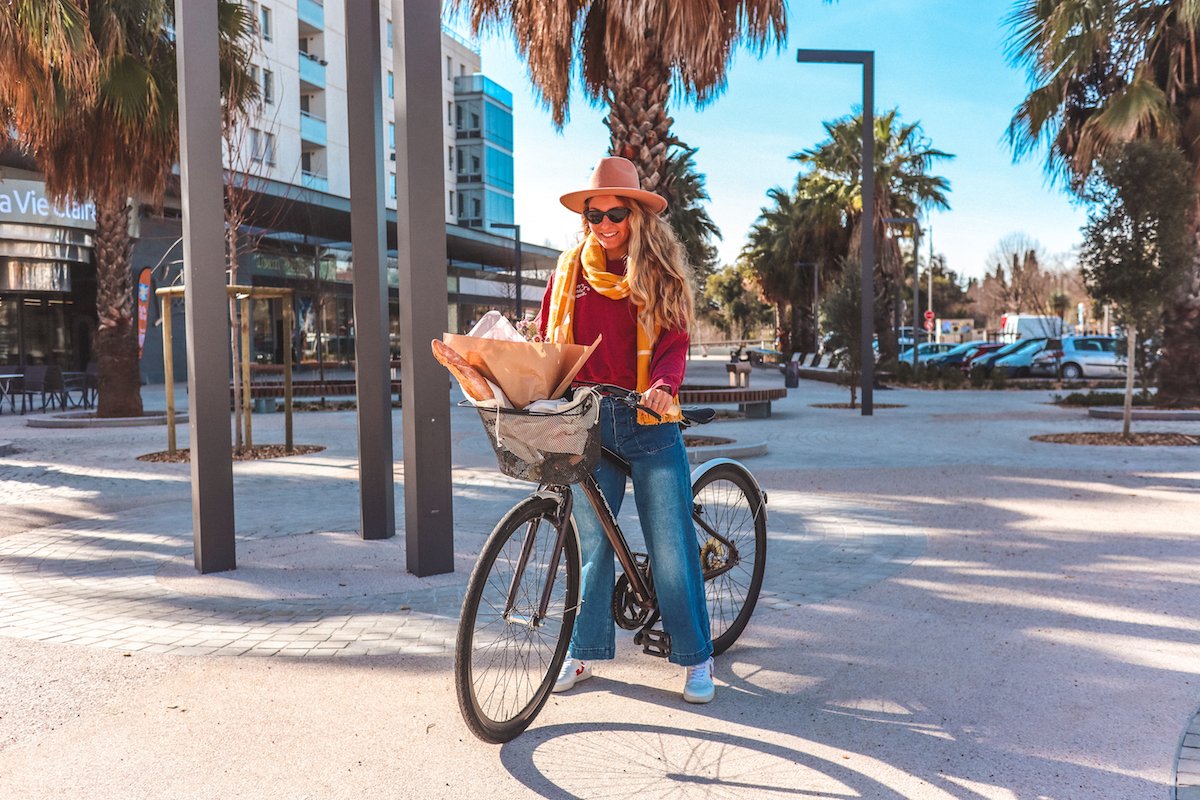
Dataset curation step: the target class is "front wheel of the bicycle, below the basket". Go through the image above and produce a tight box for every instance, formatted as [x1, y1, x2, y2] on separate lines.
[455, 495, 580, 744]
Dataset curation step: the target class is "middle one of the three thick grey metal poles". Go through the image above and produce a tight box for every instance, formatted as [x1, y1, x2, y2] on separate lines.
[346, 0, 396, 539]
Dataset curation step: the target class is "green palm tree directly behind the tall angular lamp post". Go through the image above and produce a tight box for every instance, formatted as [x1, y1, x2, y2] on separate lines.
[792, 109, 954, 360]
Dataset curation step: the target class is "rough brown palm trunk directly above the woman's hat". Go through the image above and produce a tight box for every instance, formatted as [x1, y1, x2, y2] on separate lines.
[604, 59, 674, 193]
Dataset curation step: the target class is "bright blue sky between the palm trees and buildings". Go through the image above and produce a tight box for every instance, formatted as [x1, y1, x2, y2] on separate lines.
[463, 0, 1086, 283]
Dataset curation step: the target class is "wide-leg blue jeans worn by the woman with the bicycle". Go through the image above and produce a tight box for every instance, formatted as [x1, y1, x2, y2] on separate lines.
[570, 397, 713, 667]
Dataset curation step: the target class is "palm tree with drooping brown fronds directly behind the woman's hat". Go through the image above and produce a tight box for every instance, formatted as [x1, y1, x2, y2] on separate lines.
[451, 0, 787, 192]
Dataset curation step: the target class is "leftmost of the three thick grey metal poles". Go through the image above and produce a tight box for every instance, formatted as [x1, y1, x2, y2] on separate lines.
[175, 0, 236, 572]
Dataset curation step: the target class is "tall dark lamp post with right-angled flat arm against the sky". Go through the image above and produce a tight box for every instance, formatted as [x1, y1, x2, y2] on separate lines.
[796, 49, 875, 416]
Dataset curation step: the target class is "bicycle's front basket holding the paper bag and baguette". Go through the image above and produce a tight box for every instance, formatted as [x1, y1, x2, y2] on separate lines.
[476, 391, 600, 483]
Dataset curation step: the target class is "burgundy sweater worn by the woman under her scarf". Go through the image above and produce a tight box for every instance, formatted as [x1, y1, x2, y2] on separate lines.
[538, 259, 689, 395]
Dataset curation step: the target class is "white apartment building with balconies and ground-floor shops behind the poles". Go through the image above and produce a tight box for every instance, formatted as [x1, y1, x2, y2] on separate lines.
[0, 0, 549, 380]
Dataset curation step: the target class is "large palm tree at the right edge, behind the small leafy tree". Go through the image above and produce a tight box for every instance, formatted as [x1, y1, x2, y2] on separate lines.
[1008, 0, 1200, 404]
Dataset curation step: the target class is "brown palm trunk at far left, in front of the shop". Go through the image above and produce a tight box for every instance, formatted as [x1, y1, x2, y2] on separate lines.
[95, 197, 142, 417]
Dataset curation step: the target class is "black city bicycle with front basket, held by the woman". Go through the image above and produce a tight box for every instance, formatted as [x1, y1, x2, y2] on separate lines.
[455, 385, 767, 744]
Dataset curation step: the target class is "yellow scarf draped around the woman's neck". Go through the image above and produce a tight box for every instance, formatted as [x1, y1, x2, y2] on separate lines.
[546, 234, 683, 425]
